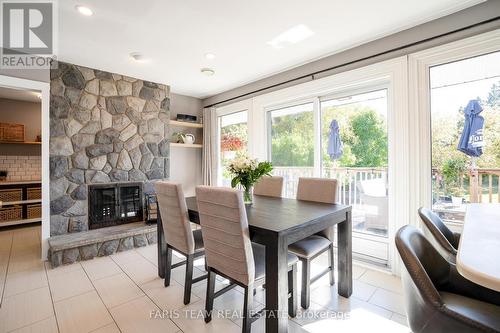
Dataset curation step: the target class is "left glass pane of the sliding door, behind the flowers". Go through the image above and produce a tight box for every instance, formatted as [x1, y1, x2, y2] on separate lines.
[268, 103, 314, 198]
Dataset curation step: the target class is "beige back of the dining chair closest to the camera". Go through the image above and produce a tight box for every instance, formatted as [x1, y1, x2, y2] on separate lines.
[196, 186, 255, 285]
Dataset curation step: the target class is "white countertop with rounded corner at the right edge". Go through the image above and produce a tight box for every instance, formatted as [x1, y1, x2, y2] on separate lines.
[457, 204, 500, 292]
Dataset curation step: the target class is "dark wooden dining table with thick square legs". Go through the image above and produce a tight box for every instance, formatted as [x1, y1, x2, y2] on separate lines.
[158, 196, 352, 332]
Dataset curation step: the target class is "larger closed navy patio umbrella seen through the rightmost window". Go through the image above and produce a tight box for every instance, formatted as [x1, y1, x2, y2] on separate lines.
[457, 99, 484, 157]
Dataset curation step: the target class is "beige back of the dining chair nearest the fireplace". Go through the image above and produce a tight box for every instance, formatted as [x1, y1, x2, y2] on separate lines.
[155, 181, 195, 254]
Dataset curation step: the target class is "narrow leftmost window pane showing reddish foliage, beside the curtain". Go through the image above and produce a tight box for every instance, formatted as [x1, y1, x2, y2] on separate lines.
[219, 111, 248, 186]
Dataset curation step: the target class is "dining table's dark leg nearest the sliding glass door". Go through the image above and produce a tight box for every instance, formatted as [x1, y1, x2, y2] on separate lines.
[337, 211, 352, 297]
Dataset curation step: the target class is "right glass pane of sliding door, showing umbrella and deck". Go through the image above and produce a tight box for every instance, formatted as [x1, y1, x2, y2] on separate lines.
[321, 89, 388, 237]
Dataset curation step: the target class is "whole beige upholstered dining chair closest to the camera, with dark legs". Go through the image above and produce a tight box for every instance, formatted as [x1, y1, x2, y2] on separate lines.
[196, 186, 298, 332]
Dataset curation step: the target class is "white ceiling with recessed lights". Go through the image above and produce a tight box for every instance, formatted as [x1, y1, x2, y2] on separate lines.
[58, 0, 483, 98]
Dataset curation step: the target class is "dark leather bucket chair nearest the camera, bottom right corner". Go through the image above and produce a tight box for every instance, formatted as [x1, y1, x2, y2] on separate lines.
[396, 225, 500, 333]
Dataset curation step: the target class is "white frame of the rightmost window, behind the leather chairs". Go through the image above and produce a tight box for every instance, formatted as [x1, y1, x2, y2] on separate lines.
[408, 29, 500, 229]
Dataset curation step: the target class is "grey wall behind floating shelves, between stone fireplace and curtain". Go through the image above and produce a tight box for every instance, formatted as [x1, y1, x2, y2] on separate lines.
[170, 94, 203, 196]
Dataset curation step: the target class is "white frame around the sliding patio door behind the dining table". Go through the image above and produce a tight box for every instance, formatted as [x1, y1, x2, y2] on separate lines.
[225, 57, 409, 274]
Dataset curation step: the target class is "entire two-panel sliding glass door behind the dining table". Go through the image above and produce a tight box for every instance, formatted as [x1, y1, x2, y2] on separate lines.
[267, 87, 389, 265]
